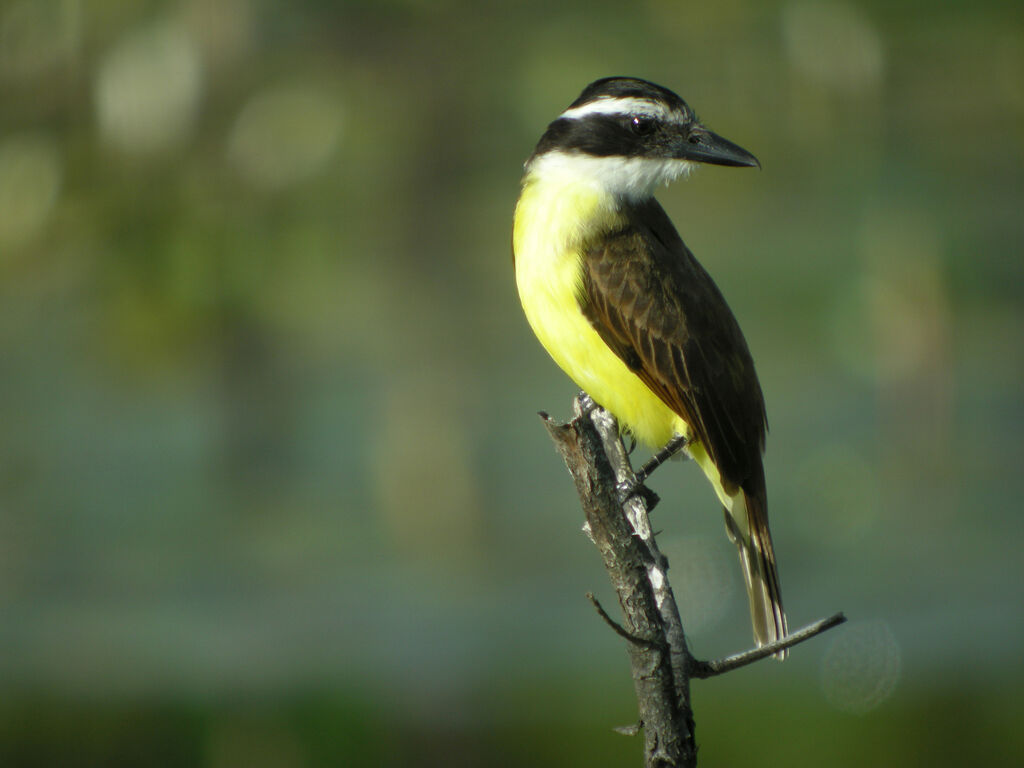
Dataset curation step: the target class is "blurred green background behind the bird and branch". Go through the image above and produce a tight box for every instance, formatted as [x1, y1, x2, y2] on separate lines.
[0, 0, 1024, 768]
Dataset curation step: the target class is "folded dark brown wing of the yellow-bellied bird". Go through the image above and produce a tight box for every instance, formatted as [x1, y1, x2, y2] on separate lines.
[580, 200, 767, 494]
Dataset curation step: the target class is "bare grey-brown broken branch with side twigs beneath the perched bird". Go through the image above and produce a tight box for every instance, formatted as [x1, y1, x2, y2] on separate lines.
[541, 395, 846, 768]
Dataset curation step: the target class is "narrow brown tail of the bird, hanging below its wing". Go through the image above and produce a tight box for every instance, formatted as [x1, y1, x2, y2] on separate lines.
[725, 480, 786, 659]
